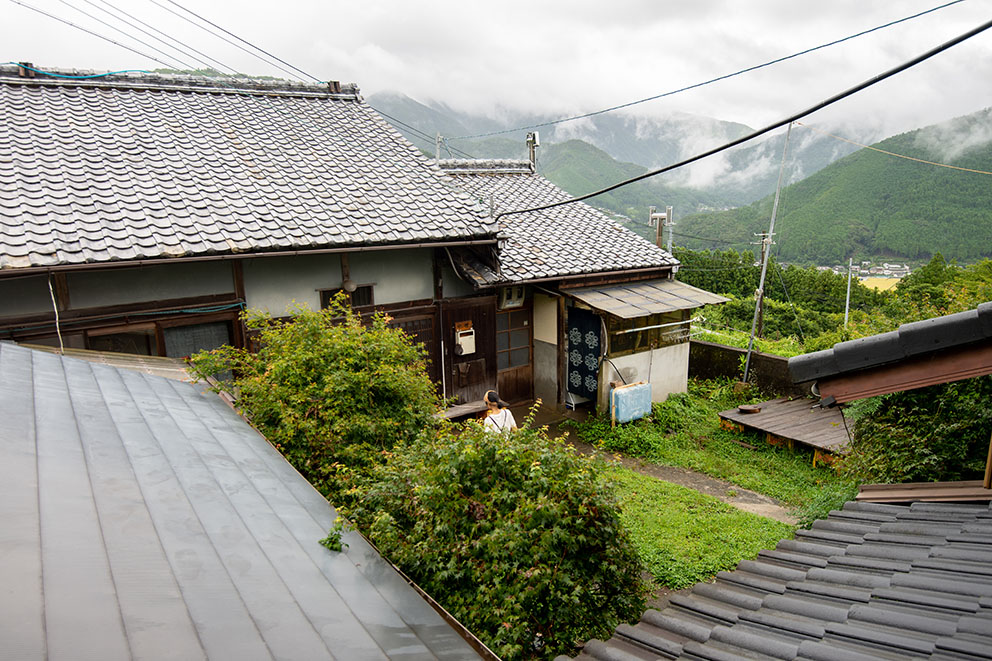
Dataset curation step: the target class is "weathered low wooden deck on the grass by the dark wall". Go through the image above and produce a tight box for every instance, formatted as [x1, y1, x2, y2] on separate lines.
[720, 398, 848, 460]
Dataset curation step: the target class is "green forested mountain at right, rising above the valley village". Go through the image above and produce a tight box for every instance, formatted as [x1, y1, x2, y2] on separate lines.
[678, 108, 992, 264]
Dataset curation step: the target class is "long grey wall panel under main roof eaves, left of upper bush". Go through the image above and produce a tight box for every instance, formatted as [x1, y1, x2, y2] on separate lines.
[67, 261, 234, 310]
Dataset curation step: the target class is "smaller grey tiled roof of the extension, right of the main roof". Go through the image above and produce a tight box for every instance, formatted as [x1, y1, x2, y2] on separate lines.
[439, 160, 678, 282]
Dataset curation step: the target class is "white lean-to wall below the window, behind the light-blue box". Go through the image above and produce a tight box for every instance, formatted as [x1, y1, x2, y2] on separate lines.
[597, 342, 689, 411]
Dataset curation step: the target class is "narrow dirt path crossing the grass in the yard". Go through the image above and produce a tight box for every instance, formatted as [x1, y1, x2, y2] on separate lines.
[550, 428, 798, 525]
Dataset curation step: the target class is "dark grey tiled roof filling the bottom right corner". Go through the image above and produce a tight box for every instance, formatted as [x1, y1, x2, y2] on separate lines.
[564, 503, 992, 661]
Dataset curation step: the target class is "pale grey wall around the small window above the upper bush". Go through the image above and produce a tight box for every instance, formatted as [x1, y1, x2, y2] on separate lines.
[243, 249, 434, 316]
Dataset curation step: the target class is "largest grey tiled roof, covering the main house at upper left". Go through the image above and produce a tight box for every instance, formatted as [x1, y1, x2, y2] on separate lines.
[0, 66, 495, 269]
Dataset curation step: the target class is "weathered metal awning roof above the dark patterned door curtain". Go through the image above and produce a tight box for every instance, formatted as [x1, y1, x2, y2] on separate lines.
[562, 279, 728, 319]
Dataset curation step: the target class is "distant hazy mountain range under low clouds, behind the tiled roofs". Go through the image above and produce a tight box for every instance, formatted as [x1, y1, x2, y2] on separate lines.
[368, 94, 880, 209]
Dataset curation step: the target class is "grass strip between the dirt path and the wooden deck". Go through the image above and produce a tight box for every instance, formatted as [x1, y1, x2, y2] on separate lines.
[574, 380, 853, 521]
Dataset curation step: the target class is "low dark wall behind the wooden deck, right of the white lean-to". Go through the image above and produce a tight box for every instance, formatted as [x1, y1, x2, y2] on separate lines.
[689, 340, 812, 397]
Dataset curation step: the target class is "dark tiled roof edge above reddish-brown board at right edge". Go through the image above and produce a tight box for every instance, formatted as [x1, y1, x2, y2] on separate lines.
[789, 302, 992, 383]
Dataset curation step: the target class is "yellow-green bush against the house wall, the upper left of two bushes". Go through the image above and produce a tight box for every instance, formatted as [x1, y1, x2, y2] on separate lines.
[191, 300, 439, 505]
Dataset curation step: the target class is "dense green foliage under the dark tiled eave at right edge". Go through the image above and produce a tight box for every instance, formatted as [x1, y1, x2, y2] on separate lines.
[841, 376, 992, 483]
